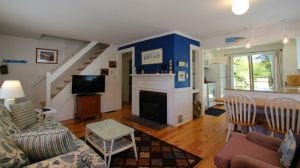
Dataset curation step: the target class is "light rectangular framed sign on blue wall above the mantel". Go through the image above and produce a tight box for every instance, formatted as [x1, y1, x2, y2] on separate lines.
[142, 48, 163, 65]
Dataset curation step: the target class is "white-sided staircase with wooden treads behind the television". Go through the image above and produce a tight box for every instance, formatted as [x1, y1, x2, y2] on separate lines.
[46, 41, 121, 120]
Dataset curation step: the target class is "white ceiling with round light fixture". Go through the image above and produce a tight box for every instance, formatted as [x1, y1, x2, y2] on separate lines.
[0, 0, 300, 44]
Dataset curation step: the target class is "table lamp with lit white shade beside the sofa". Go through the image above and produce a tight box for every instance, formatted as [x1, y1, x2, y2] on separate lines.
[0, 80, 25, 109]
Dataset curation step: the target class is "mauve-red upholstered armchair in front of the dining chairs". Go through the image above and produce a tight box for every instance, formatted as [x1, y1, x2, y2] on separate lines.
[214, 132, 300, 168]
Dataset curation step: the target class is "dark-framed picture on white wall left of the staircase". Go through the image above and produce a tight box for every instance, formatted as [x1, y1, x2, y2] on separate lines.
[36, 48, 58, 64]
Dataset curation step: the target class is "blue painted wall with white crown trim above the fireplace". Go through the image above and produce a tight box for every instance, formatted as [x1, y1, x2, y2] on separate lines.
[119, 34, 200, 88]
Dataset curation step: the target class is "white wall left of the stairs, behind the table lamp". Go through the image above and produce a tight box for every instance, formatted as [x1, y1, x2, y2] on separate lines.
[0, 35, 87, 105]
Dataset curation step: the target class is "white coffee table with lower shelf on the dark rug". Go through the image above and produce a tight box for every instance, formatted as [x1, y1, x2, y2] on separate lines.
[85, 119, 138, 167]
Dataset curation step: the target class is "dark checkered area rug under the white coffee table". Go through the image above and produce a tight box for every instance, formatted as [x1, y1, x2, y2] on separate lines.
[82, 130, 202, 168]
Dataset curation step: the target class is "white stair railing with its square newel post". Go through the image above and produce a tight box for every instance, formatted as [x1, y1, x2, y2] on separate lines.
[46, 41, 98, 106]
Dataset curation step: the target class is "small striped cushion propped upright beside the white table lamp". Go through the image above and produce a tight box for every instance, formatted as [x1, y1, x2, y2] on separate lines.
[9, 101, 38, 130]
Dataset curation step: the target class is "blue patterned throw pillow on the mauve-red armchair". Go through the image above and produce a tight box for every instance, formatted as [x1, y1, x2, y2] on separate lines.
[278, 130, 296, 168]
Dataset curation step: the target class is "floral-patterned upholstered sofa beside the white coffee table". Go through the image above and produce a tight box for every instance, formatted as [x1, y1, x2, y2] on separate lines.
[0, 103, 105, 168]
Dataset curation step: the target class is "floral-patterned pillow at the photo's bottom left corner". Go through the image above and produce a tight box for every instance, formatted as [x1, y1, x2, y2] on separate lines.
[0, 136, 30, 168]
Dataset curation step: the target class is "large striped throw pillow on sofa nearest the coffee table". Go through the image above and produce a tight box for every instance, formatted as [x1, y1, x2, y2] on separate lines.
[17, 129, 77, 162]
